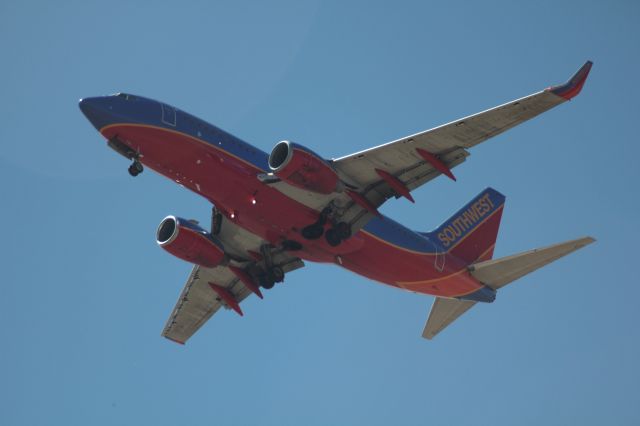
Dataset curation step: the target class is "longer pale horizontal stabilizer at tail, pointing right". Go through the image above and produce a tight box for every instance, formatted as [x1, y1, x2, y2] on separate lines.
[469, 237, 595, 290]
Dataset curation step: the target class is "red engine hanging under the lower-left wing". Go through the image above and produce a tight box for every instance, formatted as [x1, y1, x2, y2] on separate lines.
[156, 216, 225, 268]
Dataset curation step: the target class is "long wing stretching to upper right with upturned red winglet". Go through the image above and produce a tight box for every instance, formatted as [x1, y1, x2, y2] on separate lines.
[333, 61, 592, 207]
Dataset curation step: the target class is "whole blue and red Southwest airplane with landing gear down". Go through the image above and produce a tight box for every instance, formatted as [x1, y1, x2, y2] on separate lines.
[79, 61, 595, 344]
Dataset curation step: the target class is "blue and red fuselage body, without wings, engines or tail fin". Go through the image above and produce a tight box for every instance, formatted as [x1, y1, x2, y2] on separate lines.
[80, 94, 493, 297]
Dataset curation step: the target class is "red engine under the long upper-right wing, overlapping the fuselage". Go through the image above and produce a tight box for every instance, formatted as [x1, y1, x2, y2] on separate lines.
[269, 141, 340, 194]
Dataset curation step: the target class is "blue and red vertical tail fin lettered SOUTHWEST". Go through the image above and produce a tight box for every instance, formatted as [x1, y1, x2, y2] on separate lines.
[426, 188, 505, 263]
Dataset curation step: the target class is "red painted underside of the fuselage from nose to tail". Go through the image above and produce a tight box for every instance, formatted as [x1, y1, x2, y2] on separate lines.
[103, 125, 477, 296]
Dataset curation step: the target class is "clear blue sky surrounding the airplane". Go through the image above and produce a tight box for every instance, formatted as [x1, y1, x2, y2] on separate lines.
[0, 1, 640, 425]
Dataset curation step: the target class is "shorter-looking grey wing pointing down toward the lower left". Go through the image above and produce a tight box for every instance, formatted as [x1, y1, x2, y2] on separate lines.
[162, 208, 304, 344]
